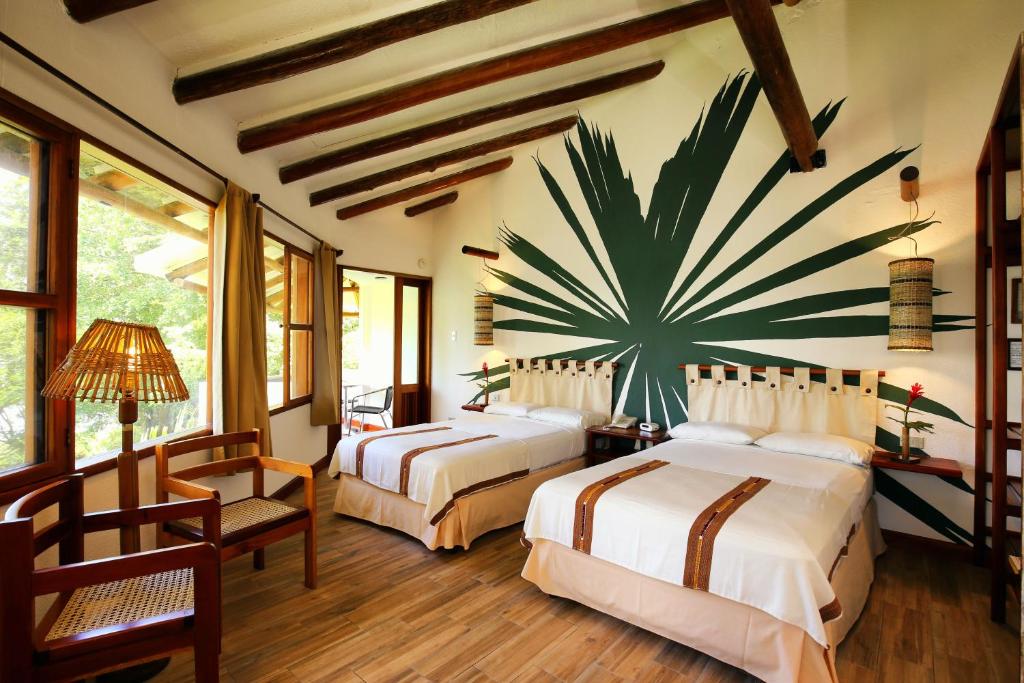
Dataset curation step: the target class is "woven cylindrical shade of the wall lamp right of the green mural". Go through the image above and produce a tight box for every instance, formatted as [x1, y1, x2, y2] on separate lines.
[889, 258, 935, 351]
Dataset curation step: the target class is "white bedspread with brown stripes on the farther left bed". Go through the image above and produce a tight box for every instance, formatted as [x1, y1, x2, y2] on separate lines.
[328, 414, 585, 520]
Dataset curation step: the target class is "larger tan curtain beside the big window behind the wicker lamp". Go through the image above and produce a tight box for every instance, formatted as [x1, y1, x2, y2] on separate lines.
[212, 181, 271, 459]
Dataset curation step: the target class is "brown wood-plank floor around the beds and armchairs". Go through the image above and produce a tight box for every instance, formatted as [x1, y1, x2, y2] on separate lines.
[155, 475, 1019, 683]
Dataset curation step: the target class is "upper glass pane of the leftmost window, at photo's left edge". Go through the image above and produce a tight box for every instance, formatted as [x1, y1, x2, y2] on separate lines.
[0, 122, 49, 292]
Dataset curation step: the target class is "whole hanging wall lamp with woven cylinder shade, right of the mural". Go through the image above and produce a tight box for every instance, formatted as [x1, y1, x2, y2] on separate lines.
[889, 166, 935, 351]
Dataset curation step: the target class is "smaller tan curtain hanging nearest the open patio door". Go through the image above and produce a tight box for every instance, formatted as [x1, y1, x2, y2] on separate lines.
[309, 242, 341, 425]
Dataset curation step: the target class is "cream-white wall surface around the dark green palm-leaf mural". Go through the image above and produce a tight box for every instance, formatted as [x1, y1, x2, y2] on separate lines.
[433, 0, 1024, 536]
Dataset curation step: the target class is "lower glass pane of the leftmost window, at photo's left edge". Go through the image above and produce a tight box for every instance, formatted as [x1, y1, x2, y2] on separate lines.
[0, 306, 46, 472]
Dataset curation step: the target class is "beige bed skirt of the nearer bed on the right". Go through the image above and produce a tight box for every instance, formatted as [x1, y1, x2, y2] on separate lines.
[522, 500, 885, 683]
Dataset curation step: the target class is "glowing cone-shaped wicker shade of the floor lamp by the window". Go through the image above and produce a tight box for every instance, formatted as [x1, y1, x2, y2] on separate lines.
[43, 319, 188, 403]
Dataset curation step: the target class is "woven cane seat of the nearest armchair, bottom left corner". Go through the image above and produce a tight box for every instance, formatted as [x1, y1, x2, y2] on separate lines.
[46, 568, 195, 641]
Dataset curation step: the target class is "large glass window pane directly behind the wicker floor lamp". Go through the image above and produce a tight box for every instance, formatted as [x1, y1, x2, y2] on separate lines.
[75, 143, 210, 458]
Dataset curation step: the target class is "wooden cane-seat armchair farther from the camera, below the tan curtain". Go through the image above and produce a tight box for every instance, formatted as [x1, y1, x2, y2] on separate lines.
[156, 429, 316, 588]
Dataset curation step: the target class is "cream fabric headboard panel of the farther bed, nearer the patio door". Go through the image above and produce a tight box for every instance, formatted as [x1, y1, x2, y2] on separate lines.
[509, 358, 614, 417]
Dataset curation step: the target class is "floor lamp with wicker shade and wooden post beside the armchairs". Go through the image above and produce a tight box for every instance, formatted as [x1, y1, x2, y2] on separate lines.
[42, 318, 188, 554]
